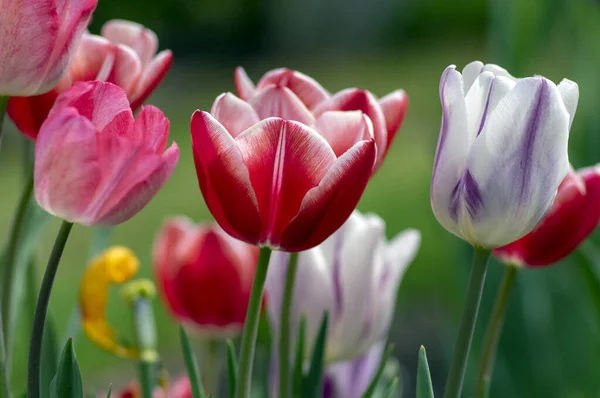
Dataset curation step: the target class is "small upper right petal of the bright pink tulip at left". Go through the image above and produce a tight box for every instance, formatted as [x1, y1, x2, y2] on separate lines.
[131, 105, 169, 154]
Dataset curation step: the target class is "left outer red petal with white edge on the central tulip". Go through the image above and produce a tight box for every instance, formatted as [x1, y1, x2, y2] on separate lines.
[190, 111, 260, 244]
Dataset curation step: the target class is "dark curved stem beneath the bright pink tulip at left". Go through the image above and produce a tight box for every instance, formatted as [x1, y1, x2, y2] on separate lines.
[27, 221, 73, 398]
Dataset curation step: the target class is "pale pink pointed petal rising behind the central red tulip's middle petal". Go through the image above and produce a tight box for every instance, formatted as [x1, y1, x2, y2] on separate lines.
[248, 85, 315, 126]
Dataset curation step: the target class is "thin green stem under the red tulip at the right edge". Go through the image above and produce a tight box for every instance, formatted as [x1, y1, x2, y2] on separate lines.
[475, 264, 518, 398]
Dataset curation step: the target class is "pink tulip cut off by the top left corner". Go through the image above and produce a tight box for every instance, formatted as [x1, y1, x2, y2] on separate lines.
[0, 0, 97, 96]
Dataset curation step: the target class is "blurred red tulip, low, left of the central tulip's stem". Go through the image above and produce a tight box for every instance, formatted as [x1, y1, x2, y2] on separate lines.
[153, 217, 258, 336]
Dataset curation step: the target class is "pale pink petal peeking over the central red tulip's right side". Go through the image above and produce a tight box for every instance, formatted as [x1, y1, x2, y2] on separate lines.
[315, 111, 373, 157]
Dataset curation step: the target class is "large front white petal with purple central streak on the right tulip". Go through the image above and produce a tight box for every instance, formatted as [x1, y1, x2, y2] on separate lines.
[464, 77, 569, 247]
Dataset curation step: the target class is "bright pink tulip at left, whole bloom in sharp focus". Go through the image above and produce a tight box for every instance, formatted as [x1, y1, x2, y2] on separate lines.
[34, 81, 179, 225]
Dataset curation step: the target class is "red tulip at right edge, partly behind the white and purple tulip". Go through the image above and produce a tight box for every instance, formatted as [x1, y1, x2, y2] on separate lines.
[494, 166, 600, 267]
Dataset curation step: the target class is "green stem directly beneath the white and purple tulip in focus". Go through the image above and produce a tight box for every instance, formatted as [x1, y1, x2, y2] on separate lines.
[444, 247, 492, 398]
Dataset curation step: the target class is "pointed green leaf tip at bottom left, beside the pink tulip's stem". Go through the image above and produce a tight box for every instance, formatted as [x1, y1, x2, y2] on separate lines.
[50, 339, 83, 398]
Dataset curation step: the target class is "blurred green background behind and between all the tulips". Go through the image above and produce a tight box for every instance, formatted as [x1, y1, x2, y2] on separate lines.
[0, 0, 600, 398]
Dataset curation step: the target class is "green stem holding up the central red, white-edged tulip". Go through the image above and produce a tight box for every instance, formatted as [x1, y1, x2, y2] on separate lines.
[235, 247, 271, 398]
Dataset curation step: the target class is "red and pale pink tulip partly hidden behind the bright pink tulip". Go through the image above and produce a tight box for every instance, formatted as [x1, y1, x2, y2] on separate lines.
[7, 20, 173, 140]
